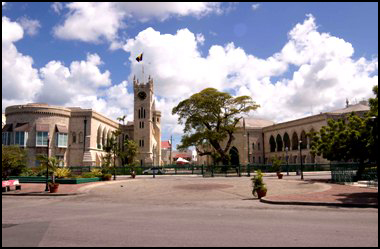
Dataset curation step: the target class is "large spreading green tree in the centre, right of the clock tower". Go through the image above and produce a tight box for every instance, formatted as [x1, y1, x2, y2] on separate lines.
[172, 88, 259, 165]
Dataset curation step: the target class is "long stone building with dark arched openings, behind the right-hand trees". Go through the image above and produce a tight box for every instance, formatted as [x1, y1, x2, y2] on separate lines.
[198, 101, 369, 165]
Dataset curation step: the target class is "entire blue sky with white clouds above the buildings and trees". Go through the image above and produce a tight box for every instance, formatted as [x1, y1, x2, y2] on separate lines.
[2, 2, 378, 149]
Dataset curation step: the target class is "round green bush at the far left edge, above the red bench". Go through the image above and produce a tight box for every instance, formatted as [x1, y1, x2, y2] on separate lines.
[1, 145, 27, 179]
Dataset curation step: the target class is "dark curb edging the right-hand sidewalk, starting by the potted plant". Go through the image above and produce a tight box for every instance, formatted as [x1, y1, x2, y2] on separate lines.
[260, 198, 378, 208]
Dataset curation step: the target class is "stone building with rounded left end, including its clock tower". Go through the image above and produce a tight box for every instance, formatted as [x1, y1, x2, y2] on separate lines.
[2, 75, 161, 166]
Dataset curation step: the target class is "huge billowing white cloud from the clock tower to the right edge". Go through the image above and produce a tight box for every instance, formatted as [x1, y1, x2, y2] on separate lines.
[123, 15, 378, 130]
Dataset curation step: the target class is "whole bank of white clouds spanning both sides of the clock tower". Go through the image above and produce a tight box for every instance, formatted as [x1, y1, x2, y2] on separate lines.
[2, 10, 378, 137]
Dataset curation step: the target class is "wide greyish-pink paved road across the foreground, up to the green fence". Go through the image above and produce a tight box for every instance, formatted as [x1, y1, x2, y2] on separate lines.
[2, 178, 378, 247]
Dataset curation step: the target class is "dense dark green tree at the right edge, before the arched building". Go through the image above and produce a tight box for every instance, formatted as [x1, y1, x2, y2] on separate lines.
[311, 86, 378, 178]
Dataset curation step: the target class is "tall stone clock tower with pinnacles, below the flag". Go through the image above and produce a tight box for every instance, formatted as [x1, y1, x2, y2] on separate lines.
[133, 76, 161, 166]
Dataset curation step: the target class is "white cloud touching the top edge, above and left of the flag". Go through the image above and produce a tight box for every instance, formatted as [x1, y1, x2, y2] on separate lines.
[53, 2, 226, 46]
